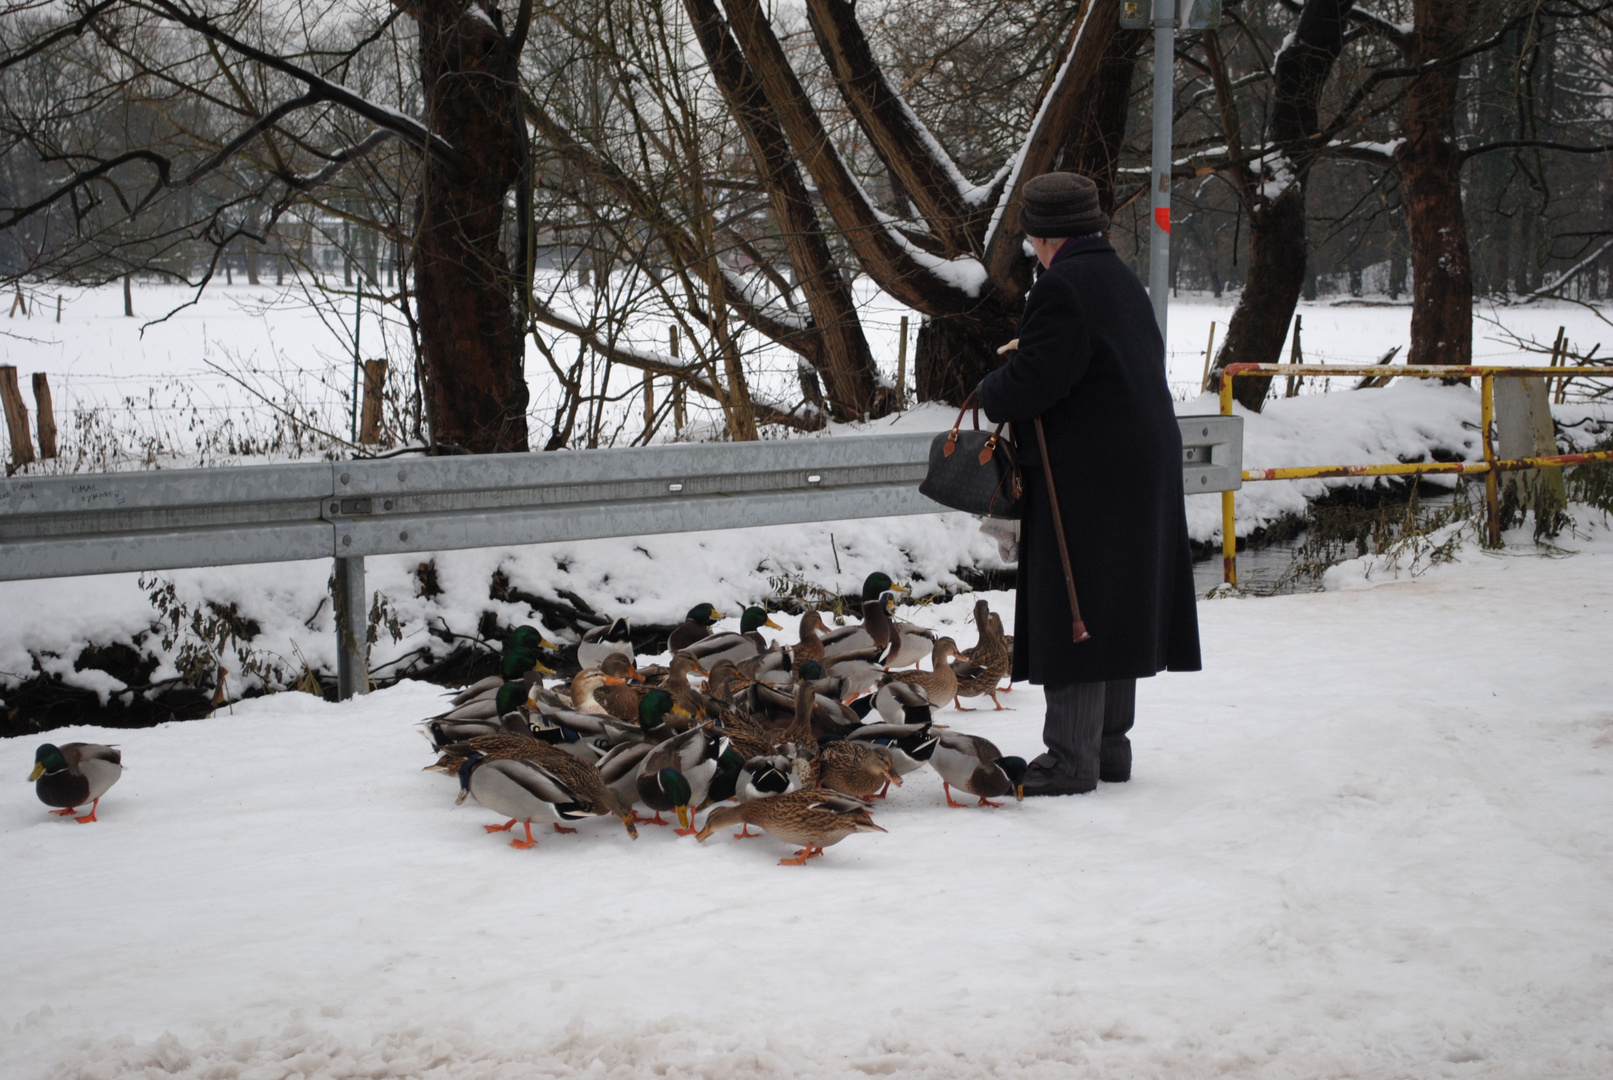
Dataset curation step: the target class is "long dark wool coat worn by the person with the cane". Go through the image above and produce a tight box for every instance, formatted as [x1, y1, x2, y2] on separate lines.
[979, 237, 1200, 687]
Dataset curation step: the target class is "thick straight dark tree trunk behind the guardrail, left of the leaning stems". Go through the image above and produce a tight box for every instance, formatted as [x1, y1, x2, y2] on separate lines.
[411, 0, 527, 453]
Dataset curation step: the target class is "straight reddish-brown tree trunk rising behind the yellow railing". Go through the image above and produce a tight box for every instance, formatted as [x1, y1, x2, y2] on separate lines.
[1395, 0, 1473, 364]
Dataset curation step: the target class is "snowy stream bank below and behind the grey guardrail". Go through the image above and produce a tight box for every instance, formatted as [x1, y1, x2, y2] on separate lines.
[0, 380, 1613, 716]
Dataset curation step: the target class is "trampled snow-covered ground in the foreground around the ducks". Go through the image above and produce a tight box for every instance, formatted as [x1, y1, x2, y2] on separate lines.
[0, 527, 1613, 1080]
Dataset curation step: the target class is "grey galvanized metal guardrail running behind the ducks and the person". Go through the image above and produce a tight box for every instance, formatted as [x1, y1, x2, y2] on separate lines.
[0, 416, 1244, 698]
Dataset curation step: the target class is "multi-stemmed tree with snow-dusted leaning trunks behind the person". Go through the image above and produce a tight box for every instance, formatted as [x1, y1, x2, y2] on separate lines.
[527, 0, 1144, 419]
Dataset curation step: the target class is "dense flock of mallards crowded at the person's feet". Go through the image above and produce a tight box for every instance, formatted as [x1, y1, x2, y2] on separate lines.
[421, 574, 1026, 866]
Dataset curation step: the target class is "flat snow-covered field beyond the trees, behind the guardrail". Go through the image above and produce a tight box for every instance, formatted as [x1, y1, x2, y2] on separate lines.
[0, 280, 1613, 469]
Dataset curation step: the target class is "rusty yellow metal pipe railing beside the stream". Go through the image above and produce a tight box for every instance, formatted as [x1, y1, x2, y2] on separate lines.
[1219, 364, 1613, 585]
